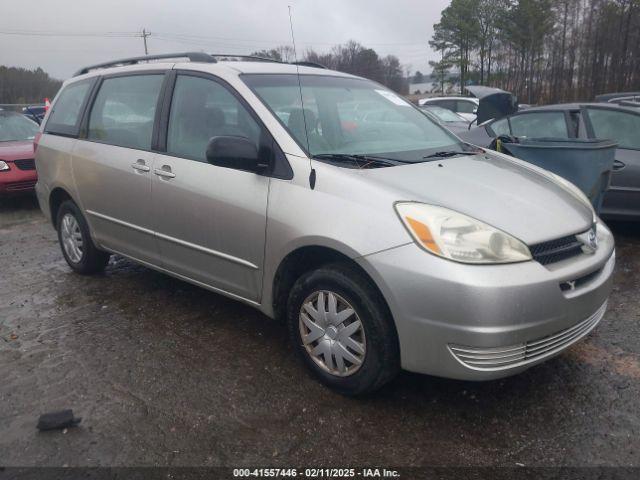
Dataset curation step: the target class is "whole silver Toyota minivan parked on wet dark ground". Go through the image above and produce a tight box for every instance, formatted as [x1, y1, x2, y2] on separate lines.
[36, 53, 615, 395]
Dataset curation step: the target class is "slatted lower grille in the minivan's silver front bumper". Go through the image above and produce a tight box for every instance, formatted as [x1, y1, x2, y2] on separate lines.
[449, 302, 607, 371]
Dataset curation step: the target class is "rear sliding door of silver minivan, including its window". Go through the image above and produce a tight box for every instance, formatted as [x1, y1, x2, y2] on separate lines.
[73, 73, 164, 265]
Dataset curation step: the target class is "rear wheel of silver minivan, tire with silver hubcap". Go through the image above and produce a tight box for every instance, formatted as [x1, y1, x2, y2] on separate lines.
[56, 200, 111, 275]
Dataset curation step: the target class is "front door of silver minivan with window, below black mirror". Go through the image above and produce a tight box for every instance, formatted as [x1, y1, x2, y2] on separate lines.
[152, 73, 270, 301]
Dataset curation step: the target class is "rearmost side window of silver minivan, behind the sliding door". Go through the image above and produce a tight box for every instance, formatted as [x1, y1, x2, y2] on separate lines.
[45, 79, 95, 136]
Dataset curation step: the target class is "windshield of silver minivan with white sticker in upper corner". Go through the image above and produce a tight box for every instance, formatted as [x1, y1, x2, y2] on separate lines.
[242, 74, 465, 162]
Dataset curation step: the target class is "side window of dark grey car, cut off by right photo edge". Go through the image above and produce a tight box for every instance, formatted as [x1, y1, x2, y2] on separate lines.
[587, 108, 640, 150]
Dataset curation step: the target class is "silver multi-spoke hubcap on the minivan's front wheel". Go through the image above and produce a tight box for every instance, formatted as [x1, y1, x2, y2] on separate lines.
[299, 290, 366, 377]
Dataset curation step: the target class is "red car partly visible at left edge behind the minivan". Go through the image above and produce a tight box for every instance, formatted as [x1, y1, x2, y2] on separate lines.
[0, 110, 39, 196]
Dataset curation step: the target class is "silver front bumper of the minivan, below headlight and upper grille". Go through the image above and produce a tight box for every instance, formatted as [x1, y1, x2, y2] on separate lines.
[357, 223, 615, 380]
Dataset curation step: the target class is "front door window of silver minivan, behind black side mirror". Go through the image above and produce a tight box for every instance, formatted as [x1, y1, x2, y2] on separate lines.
[167, 75, 261, 162]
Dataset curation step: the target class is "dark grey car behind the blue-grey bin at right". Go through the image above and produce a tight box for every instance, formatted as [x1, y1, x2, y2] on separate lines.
[459, 103, 640, 220]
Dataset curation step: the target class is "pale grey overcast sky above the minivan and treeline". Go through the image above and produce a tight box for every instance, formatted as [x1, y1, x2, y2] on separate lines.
[0, 0, 449, 79]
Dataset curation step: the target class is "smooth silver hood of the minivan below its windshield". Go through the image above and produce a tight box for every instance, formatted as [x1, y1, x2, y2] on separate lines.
[368, 154, 593, 245]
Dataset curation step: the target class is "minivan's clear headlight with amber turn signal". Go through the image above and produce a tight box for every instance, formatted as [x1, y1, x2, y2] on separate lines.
[395, 202, 531, 264]
